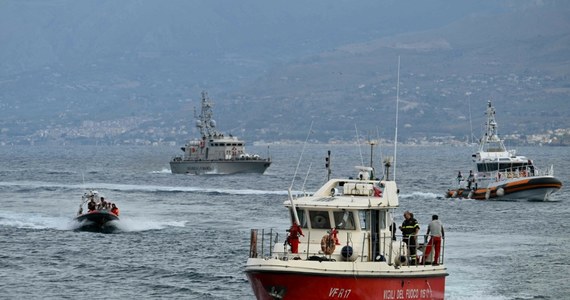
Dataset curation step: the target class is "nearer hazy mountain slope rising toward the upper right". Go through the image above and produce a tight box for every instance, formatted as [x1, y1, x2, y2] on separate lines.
[231, 2, 570, 143]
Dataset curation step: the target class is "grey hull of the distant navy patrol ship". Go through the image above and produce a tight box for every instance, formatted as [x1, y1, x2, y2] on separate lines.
[170, 160, 271, 175]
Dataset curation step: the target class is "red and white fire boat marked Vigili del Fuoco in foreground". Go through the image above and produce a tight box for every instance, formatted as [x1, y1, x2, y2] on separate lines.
[245, 158, 448, 300]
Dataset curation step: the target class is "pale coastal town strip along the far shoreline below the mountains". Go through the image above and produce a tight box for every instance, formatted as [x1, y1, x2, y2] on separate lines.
[0, 117, 570, 146]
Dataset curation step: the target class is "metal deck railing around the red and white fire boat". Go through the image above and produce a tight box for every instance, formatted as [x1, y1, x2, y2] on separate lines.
[249, 229, 445, 267]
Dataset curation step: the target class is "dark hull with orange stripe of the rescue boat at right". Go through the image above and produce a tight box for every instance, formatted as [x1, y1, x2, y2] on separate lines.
[446, 176, 562, 201]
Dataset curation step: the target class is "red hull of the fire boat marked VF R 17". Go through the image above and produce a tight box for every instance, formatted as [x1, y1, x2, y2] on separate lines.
[247, 272, 445, 300]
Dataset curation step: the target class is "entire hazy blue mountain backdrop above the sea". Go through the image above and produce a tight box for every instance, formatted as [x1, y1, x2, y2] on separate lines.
[0, 0, 570, 143]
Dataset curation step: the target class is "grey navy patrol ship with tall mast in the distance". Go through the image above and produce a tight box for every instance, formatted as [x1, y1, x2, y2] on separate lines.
[170, 92, 271, 175]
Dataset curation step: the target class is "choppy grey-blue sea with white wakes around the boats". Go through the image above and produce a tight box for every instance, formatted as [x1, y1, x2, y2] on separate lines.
[0, 145, 570, 300]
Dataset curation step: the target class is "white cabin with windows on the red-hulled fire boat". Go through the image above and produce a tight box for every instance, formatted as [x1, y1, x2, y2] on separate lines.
[274, 179, 406, 263]
